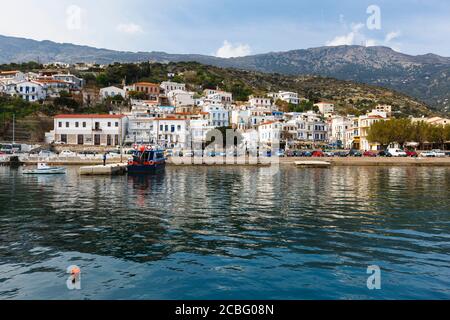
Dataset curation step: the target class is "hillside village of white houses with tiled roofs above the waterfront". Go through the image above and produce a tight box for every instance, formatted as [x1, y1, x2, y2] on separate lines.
[0, 64, 450, 151]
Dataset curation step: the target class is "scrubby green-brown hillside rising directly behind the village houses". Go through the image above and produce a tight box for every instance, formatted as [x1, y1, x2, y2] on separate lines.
[89, 62, 431, 116]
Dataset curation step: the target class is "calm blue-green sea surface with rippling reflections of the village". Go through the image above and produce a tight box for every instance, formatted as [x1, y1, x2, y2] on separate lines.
[0, 167, 450, 299]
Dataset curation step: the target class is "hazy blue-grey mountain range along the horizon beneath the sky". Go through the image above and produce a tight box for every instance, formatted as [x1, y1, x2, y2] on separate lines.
[0, 36, 450, 113]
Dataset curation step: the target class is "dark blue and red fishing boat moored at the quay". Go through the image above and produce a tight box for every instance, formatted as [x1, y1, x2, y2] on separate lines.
[127, 146, 166, 174]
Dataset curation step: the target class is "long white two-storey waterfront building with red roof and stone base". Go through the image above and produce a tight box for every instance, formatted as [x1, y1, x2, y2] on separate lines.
[54, 114, 128, 146]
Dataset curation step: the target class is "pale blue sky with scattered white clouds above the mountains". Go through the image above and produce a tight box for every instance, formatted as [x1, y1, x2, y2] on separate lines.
[0, 0, 450, 57]
